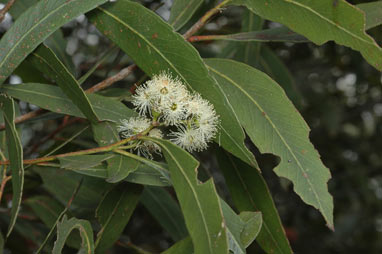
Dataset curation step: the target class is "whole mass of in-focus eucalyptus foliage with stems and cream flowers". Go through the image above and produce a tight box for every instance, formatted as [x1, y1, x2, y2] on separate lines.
[0, 0, 382, 254]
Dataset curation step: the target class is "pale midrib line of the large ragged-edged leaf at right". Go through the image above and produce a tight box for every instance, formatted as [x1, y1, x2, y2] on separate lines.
[208, 66, 326, 217]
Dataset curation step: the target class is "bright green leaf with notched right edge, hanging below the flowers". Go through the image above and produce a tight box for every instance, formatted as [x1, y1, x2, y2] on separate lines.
[150, 139, 228, 254]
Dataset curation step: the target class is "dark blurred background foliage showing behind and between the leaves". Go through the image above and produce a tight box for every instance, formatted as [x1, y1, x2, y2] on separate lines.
[0, 1, 382, 254]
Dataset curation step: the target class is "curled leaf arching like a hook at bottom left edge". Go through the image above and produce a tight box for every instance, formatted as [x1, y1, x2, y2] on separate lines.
[52, 215, 94, 254]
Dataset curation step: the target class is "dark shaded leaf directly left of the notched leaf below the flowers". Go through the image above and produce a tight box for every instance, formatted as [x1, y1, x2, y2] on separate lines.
[140, 186, 188, 241]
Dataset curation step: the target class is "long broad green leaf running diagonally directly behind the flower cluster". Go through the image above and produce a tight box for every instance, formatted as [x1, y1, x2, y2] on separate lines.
[89, 0, 256, 168]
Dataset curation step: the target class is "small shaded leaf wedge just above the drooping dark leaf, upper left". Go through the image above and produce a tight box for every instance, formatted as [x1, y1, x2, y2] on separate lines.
[44, 29, 76, 76]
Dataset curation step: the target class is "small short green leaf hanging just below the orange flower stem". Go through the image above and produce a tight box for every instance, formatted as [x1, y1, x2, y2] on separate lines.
[106, 155, 141, 183]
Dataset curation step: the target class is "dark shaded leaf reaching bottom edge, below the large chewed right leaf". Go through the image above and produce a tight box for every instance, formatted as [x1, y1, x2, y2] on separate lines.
[217, 149, 293, 254]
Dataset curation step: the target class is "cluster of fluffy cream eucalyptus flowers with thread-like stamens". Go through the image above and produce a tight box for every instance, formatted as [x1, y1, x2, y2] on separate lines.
[119, 72, 219, 158]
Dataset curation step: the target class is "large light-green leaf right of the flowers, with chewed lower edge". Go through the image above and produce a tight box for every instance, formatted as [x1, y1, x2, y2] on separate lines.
[206, 59, 333, 229]
